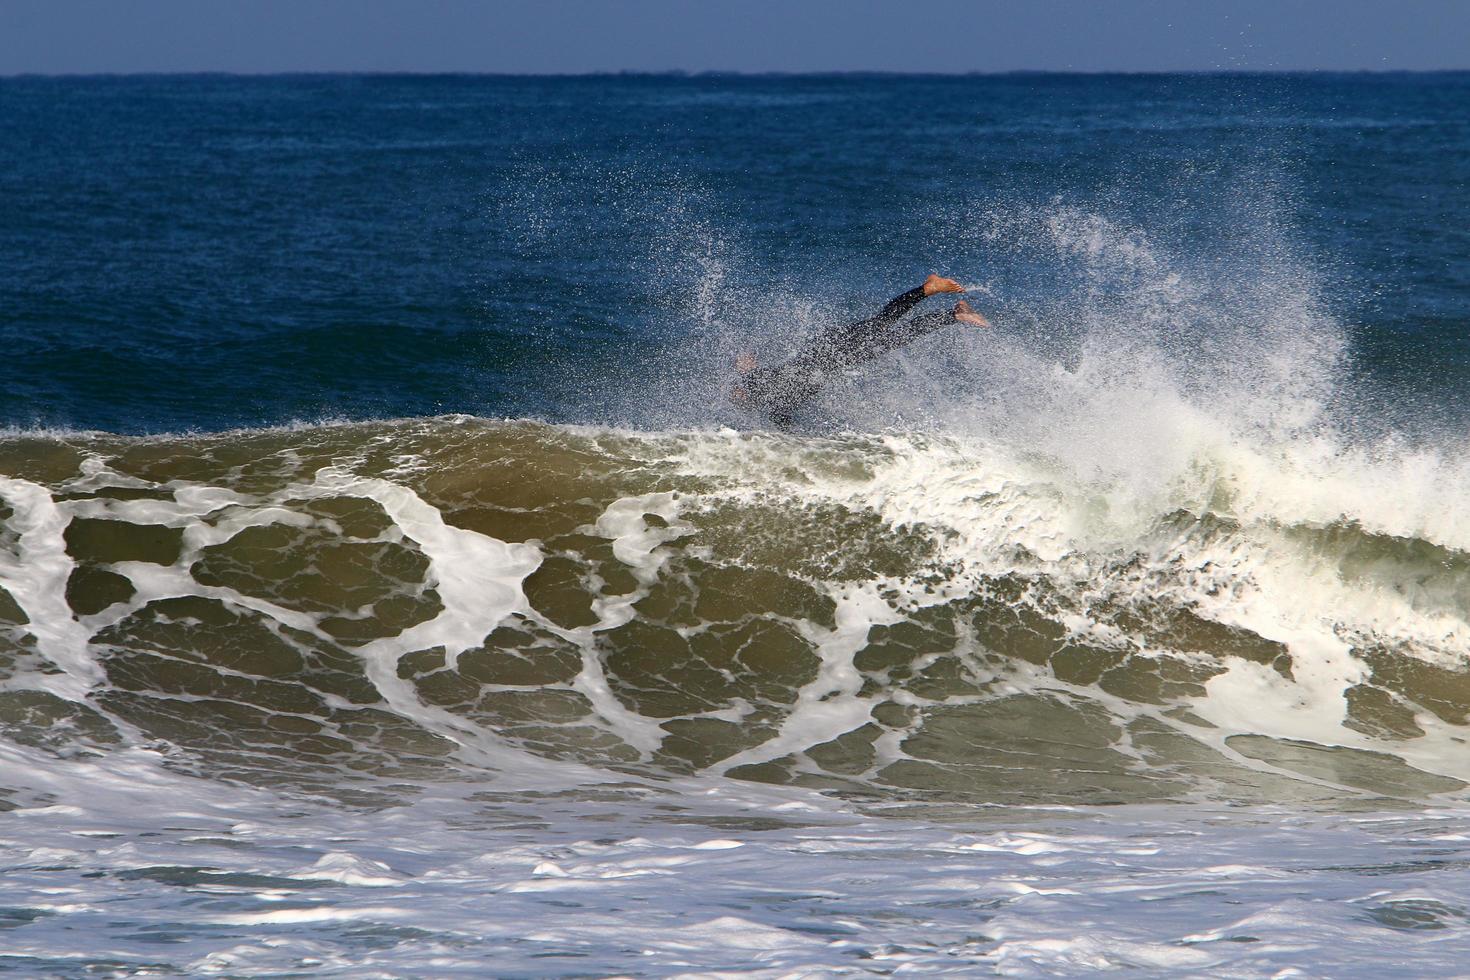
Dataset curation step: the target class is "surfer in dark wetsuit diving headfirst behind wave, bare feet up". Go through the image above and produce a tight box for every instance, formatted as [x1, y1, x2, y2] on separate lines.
[731, 275, 991, 426]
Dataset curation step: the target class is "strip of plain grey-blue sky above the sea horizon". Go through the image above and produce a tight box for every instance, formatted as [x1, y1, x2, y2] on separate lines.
[0, 0, 1470, 75]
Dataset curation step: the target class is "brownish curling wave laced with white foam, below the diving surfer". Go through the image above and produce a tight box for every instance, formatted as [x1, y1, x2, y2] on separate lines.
[0, 416, 1470, 805]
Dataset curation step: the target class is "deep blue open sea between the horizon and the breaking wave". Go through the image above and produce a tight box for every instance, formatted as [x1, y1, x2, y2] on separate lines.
[0, 73, 1470, 432]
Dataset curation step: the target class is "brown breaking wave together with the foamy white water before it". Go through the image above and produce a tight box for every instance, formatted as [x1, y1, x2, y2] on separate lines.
[0, 399, 1470, 976]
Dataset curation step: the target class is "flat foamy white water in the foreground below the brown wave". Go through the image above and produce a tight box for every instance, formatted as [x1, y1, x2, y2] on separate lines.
[0, 740, 1470, 977]
